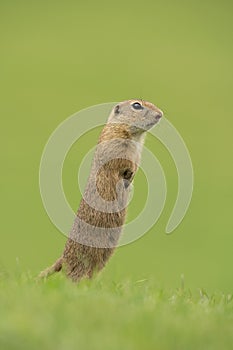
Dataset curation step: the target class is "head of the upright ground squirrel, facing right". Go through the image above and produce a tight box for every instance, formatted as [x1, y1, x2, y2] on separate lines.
[108, 100, 163, 134]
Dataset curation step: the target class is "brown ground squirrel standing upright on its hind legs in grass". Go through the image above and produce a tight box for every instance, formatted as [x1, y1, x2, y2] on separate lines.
[39, 100, 163, 281]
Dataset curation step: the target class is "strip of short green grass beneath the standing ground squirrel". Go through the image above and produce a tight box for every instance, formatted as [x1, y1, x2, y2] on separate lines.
[0, 274, 233, 350]
